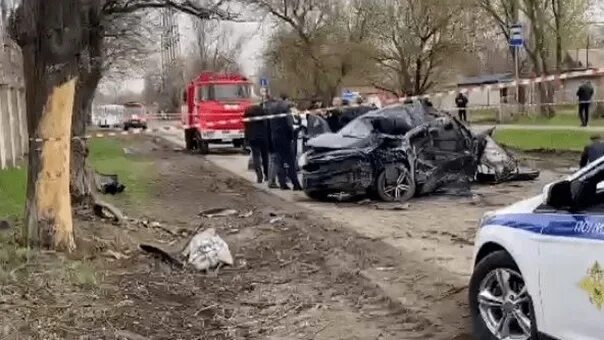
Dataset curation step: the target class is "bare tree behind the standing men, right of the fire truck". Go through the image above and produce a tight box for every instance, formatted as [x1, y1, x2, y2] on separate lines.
[260, 0, 373, 101]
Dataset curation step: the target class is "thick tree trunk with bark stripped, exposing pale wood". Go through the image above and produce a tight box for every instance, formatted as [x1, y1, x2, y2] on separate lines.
[17, 0, 88, 251]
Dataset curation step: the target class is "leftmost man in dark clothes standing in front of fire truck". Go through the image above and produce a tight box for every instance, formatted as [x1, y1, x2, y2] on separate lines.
[244, 105, 270, 183]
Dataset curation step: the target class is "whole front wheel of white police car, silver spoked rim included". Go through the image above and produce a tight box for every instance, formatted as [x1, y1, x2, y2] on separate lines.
[469, 251, 537, 340]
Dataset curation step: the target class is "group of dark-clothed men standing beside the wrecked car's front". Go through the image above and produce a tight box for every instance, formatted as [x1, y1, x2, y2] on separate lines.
[244, 96, 302, 191]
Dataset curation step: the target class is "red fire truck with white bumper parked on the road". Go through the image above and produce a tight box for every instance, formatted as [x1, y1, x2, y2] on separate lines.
[182, 72, 252, 154]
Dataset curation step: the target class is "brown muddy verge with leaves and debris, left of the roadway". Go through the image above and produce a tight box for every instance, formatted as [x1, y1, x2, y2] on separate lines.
[0, 138, 494, 340]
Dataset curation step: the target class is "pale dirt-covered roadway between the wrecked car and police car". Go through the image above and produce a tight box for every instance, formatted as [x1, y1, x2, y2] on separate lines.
[147, 125, 578, 339]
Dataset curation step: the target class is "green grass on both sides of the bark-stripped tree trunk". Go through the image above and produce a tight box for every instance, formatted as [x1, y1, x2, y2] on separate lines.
[0, 139, 156, 220]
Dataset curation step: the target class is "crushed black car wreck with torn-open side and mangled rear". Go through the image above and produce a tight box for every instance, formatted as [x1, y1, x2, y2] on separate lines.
[299, 101, 539, 202]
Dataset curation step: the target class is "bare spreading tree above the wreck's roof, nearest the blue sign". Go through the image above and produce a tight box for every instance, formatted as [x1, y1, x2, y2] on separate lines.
[373, 0, 464, 95]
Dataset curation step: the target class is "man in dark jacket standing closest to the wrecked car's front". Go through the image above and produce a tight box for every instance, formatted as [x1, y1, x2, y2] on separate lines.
[267, 100, 302, 190]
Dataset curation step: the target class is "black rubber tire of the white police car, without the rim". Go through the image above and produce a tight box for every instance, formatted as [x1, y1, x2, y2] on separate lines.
[469, 250, 538, 340]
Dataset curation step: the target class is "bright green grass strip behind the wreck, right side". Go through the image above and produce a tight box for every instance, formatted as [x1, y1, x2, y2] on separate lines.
[495, 129, 592, 151]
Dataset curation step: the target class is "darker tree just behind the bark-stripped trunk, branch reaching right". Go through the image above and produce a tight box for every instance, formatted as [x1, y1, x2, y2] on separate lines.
[70, 0, 237, 209]
